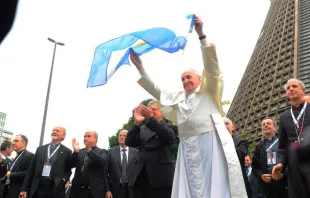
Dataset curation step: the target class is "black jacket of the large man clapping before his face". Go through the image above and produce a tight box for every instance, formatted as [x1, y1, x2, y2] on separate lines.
[126, 118, 178, 187]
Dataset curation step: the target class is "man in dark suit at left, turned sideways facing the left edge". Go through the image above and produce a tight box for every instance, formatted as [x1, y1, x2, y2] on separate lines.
[3, 135, 34, 198]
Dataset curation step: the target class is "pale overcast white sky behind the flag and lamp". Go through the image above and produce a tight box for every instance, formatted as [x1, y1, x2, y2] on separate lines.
[0, 0, 270, 152]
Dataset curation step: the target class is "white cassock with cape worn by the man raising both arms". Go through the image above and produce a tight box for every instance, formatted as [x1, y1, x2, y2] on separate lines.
[138, 39, 247, 198]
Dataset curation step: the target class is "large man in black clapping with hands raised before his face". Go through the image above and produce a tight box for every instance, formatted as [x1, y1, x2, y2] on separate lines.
[126, 102, 178, 198]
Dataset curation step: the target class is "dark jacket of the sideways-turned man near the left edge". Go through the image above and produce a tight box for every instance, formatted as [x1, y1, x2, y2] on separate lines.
[4, 150, 34, 197]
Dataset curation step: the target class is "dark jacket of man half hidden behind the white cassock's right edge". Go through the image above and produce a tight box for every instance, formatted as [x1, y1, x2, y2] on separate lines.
[232, 134, 252, 198]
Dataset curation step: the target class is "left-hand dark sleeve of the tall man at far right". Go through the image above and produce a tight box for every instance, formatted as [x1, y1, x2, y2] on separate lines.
[278, 117, 288, 170]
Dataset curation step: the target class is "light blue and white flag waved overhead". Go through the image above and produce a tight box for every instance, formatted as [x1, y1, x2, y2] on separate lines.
[87, 14, 194, 87]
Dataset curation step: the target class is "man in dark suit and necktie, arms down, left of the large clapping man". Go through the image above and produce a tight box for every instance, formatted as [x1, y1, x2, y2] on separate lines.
[106, 130, 138, 198]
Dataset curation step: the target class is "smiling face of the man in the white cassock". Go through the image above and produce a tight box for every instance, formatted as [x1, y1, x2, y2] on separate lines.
[181, 71, 200, 94]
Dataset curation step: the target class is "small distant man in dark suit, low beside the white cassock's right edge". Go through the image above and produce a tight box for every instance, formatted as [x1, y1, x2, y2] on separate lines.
[244, 155, 265, 198]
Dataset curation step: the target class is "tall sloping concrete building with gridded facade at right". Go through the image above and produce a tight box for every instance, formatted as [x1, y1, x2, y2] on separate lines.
[227, 0, 310, 141]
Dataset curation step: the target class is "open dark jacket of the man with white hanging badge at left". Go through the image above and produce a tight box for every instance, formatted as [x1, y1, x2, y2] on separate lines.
[21, 144, 72, 198]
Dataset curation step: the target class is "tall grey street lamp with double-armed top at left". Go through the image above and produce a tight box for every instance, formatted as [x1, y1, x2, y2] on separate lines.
[39, 38, 65, 146]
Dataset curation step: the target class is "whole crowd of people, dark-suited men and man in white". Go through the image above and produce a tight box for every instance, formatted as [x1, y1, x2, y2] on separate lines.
[0, 16, 310, 198]
